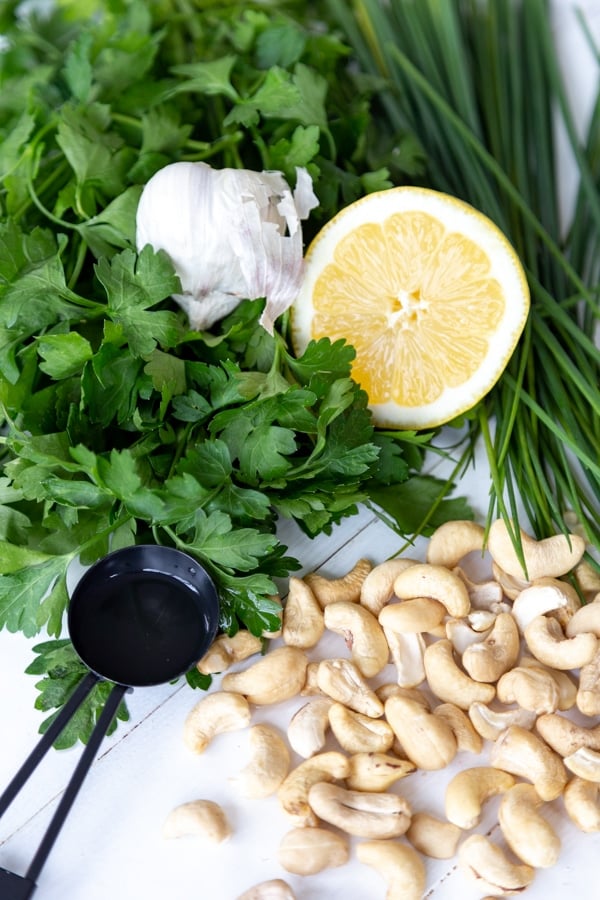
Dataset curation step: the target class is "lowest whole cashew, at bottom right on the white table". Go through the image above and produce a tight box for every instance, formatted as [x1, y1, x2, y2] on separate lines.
[458, 834, 535, 897]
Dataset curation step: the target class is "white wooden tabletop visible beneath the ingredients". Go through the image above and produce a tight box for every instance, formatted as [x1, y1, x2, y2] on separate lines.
[0, 0, 600, 900]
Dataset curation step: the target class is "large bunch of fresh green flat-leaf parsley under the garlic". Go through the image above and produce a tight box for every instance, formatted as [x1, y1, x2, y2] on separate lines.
[0, 0, 468, 745]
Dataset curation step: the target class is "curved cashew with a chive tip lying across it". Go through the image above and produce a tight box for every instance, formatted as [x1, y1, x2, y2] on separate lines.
[488, 519, 585, 581]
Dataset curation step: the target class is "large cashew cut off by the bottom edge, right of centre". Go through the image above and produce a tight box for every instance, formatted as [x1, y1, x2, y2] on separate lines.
[356, 841, 426, 900]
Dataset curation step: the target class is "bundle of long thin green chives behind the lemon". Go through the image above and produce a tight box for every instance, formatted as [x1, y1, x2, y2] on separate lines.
[330, 0, 600, 564]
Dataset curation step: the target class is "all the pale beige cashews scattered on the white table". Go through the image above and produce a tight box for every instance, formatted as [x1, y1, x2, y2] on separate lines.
[165, 520, 600, 900]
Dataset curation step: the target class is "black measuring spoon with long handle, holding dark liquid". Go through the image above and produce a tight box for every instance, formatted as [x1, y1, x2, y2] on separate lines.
[0, 544, 219, 900]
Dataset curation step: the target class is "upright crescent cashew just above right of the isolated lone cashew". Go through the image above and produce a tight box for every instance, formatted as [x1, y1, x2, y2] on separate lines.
[231, 723, 290, 800]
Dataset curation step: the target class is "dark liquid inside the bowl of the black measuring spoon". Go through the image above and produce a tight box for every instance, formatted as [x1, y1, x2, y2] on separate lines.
[69, 572, 210, 686]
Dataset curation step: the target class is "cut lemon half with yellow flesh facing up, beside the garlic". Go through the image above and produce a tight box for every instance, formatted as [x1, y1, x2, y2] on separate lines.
[291, 187, 529, 429]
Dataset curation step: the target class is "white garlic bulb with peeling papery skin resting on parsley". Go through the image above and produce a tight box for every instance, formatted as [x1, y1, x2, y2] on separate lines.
[136, 162, 319, 333]
